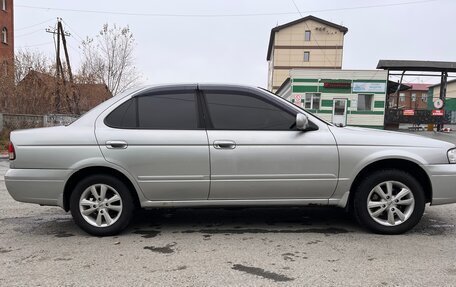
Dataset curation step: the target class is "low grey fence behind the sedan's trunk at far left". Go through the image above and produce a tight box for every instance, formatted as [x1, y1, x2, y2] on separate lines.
[0, 113, 78, 131]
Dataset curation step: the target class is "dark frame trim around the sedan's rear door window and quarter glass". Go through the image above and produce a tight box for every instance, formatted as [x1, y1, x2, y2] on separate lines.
[103, 89, 206, 131]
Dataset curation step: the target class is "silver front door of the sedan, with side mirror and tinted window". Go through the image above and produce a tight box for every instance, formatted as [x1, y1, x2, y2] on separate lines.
[200, 85, 338, 200]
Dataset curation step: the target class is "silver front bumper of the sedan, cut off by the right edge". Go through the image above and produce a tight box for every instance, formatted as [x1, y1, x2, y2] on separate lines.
[425, 164, 456, 205]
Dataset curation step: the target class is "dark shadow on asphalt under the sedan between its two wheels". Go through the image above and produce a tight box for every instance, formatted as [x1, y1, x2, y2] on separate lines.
[126, 207, 361, 237]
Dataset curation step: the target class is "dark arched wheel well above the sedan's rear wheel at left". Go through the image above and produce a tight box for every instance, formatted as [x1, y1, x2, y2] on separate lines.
[63, 166, 140, 211]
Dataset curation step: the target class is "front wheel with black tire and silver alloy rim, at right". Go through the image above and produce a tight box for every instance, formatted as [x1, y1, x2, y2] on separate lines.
[354, 169, 426, 234]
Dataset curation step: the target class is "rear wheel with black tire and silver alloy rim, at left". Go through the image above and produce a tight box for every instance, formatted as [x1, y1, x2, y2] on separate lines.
[70, 175, 135, 236]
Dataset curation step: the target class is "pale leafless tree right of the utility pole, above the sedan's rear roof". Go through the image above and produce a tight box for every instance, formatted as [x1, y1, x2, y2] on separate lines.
[78, 24, 141, 95]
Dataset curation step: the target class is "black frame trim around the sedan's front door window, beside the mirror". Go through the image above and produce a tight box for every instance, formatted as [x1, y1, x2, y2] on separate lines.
[200, 89, 302, 132]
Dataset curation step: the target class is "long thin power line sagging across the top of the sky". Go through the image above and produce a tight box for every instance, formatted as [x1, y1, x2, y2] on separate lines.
[15, 0, 441, 18]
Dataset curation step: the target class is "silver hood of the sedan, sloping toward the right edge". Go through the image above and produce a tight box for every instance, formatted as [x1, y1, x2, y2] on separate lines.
[330, 126, 455, 149]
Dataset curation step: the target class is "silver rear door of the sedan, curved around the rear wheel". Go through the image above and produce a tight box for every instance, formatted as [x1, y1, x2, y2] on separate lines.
[96, 85, 210, 200]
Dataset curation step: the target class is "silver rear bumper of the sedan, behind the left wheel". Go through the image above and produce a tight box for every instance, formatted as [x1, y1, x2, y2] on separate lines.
[5, 169, 70, 208]
